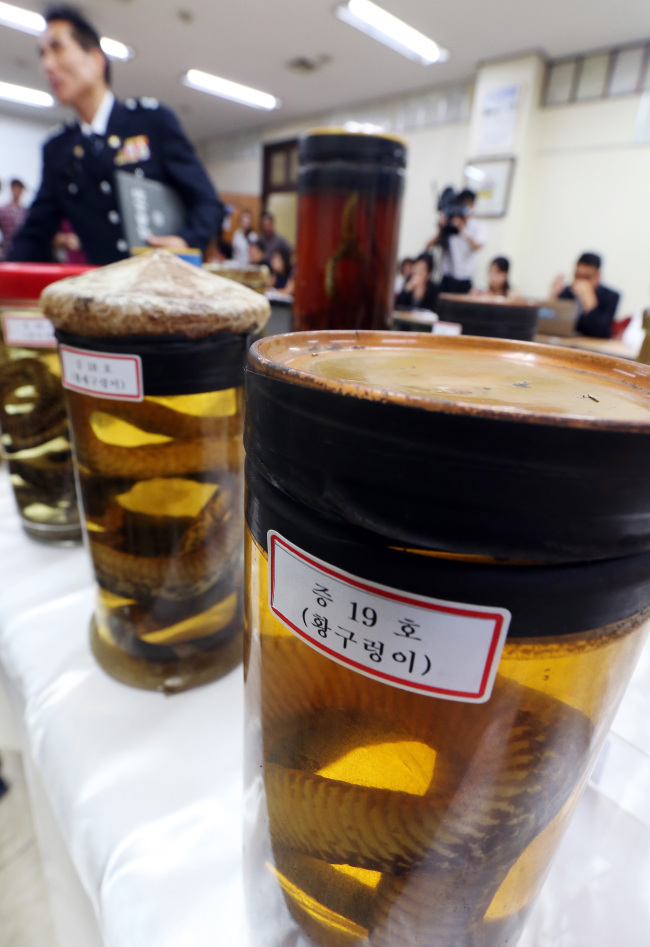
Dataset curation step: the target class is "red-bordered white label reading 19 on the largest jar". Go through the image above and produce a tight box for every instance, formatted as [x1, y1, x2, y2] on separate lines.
[268, 530, 511, 704]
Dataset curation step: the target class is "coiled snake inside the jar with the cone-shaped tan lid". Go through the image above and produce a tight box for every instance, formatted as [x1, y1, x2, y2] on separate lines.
[69, 393, 243, 602]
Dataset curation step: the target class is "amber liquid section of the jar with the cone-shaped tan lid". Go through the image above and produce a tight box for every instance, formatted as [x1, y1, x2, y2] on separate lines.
[67, 388, 243, 692]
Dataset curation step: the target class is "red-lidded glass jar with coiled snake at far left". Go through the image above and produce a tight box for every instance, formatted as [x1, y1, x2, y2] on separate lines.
[0, 263, 89, 544]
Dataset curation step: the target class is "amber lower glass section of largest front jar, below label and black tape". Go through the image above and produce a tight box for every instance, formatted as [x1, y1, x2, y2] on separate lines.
[245, 534, 650, 947]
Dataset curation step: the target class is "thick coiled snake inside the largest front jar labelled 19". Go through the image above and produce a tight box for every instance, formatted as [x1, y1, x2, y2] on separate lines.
[248, 584, 604, 947]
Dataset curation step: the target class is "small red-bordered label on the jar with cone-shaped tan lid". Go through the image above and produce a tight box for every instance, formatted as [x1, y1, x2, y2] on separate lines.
[59, 345, 144, 401]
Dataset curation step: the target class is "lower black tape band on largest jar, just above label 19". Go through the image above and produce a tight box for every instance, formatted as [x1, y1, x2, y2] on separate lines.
[246, 458, 650, 638]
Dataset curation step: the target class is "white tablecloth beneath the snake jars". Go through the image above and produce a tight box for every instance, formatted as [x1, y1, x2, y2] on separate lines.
[0, 474, 650, 947]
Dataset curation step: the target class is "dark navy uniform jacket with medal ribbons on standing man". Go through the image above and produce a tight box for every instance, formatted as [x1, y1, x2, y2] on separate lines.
[10, 98, 222, 266]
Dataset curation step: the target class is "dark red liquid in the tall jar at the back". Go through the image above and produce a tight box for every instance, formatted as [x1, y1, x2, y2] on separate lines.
[293, 189, 400, 331]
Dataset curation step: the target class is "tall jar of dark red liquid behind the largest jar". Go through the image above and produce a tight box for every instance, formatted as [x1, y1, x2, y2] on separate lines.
[293, 128, 406, 330]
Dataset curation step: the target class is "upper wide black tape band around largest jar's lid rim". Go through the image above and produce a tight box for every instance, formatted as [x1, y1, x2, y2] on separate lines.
[244, 367, 650, 563]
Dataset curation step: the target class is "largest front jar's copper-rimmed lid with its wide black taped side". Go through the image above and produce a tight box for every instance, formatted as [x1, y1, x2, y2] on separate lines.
[245, 332, 650, 564]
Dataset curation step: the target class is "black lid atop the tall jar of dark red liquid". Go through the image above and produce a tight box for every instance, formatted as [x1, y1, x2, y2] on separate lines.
[298, 127, 406, 168]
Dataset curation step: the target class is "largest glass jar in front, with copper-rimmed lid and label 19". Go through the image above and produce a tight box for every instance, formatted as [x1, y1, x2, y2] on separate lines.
[245, 333, 650, 947]
